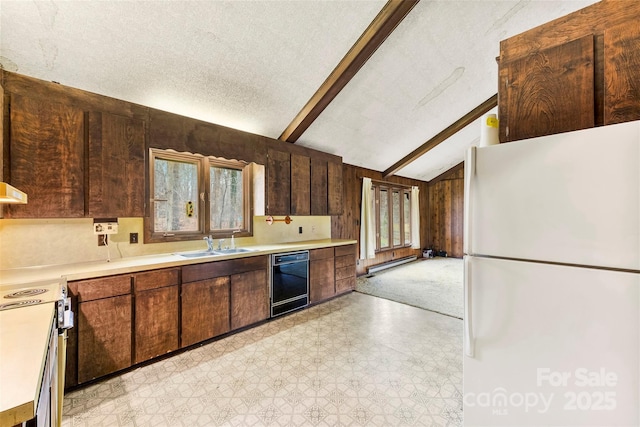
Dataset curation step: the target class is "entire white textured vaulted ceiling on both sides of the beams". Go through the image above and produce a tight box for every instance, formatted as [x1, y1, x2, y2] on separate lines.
[0, 0, 595, 181]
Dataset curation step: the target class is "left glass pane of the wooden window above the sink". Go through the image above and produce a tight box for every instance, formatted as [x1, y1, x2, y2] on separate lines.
[153, 157, 199, 232]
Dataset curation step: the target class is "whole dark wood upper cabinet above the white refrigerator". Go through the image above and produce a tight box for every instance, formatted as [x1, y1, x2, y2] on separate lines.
[498, 0, 640, 142]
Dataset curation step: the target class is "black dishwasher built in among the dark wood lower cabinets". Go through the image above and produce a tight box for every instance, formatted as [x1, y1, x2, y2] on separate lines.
[271, 251, 309, 317]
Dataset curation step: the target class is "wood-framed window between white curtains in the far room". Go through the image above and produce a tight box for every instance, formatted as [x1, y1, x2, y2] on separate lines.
[371, 183, 411, 252]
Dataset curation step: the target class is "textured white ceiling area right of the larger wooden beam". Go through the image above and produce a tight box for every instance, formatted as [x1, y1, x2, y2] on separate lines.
[300, 1, 594, 181]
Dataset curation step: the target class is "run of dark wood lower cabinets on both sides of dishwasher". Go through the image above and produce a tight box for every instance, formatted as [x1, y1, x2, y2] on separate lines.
[66, 252, 355, 387]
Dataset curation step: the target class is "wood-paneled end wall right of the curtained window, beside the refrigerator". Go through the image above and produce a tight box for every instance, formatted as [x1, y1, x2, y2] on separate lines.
[426, 163, 464, 258]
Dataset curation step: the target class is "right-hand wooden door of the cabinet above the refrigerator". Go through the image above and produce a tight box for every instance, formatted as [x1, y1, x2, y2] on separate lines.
[604, 20, 640, 125]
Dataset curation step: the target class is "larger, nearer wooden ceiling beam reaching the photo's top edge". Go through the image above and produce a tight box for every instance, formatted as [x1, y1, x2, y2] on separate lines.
[278, 0, 419, 142]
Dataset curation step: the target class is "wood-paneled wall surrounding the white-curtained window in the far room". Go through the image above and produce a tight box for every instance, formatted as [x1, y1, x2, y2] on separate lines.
[331, 164, 429, 275]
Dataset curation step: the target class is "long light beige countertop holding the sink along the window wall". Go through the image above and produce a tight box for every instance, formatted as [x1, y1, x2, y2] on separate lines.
[0, 239, 357, 287]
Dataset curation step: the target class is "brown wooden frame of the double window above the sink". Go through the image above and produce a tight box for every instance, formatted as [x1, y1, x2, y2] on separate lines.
[144, 148, 253, 243]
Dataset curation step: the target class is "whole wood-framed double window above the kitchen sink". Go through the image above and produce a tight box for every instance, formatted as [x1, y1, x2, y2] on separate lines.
[146, 149, 252, 242]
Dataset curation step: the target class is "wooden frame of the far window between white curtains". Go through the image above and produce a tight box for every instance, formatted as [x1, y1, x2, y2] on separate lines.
[371, 182, 412, 253]
